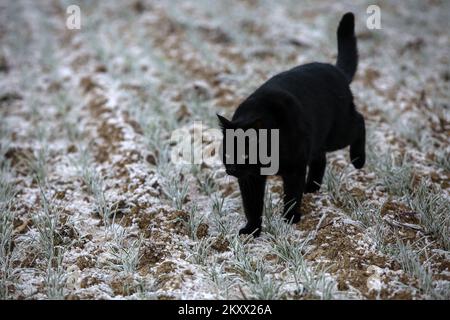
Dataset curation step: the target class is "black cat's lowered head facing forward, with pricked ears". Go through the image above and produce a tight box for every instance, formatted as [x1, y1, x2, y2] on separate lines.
[217, 115, 263, 178]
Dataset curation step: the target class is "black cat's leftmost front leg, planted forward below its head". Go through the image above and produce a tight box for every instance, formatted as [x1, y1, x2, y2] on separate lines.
[238, 176, 266, 237]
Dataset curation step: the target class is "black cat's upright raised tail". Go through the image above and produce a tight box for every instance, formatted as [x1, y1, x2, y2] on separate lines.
[336, 12, 358, 83]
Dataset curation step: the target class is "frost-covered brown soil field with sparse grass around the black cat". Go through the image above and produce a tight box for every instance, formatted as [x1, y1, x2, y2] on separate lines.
[0, 0, 450, 299]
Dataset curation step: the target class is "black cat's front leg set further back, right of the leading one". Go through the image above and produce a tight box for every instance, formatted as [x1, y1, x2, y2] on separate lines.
[282, 164, 306, 223]
